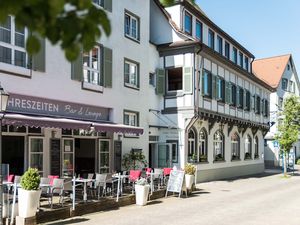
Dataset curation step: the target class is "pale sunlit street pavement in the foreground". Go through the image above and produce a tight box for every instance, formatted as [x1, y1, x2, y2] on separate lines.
[44, 173, 300, 225]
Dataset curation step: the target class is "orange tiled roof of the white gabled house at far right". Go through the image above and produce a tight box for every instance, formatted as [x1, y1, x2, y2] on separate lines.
[252, 54, 291, 89]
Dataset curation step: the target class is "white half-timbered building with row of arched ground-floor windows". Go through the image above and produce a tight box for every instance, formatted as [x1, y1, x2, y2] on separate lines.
[150, 1, 273, 181]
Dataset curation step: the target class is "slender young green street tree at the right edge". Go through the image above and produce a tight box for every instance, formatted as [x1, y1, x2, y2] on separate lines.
[275, 96, 300, 176]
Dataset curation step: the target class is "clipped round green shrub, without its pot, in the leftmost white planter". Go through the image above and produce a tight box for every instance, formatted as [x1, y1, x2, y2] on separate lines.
[21, 168, 41, 191]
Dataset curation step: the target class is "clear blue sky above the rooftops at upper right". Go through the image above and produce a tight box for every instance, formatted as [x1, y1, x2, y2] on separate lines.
[196, 0, 300, 68]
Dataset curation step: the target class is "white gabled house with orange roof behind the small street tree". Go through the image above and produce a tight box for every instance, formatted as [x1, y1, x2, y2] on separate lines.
[252, 54, 300, 166]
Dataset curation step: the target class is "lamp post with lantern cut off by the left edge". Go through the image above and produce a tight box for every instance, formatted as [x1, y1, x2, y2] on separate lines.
[0, 84, 9, 225]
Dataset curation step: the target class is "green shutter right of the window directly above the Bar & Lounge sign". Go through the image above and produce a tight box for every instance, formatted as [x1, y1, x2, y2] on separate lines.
[103, 47, 112, 88]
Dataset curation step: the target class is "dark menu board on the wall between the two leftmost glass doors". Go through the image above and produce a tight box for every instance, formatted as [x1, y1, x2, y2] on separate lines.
[50, 138, 61, 176]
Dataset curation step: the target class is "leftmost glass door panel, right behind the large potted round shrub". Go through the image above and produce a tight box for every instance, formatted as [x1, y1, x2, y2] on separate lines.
[29, 137, 44, 175]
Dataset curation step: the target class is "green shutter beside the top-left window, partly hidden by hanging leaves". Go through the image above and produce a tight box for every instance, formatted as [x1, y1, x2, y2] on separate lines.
[32, 36, 46, 72]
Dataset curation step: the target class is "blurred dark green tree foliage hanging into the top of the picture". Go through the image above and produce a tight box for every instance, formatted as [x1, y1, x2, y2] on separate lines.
[0, 0, 193, 61]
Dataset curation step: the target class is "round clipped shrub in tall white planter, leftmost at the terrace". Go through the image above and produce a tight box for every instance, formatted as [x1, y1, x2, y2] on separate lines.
[18, 168, 42, 218]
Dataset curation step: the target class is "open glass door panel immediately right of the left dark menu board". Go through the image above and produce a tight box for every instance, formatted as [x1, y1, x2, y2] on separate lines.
[61, 138, 75, 177]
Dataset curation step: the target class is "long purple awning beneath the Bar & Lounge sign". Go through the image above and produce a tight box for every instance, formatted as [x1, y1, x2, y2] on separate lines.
[2, 114, 144, 135]
